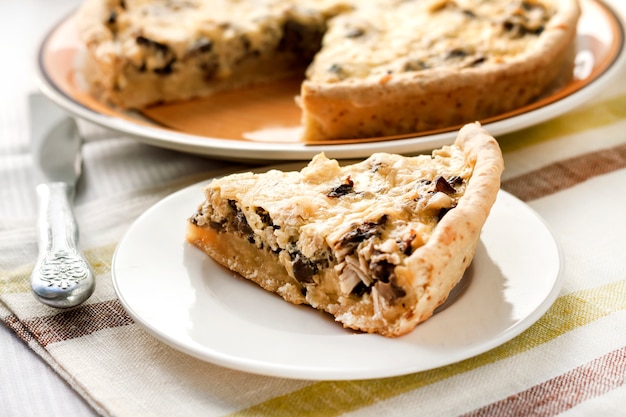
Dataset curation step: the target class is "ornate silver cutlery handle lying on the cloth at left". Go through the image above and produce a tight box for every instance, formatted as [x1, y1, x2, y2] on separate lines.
[30, 182, 95, 308]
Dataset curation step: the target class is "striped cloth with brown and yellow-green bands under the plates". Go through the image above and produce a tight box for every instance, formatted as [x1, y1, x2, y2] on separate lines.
[0, 64, 626, 417]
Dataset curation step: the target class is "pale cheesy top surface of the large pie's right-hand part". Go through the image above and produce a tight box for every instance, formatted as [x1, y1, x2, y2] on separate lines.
[307, 0, 554, 82]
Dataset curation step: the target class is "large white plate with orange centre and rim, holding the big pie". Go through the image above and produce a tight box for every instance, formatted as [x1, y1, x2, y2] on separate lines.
[38, 0, 624, 160]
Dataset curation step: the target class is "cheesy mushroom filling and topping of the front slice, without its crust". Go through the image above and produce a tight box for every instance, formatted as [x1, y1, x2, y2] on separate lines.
[192, 146, 473, 295]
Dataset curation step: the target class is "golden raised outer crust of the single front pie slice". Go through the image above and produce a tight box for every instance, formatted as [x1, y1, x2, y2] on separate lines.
[394, 123, 504, 334]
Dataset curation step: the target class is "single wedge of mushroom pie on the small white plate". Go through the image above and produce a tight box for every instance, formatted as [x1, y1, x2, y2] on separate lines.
[187, 123, 503, 337]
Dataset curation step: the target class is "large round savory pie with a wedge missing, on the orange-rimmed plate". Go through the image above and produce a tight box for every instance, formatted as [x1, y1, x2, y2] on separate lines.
[77, 0, 580, 141]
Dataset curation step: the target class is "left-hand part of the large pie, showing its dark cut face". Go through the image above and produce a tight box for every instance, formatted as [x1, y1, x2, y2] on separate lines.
[76, 0, 342, 110]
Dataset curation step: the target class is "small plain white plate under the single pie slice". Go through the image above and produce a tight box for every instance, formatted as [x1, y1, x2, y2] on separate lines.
[112, 177, 561, 380]
